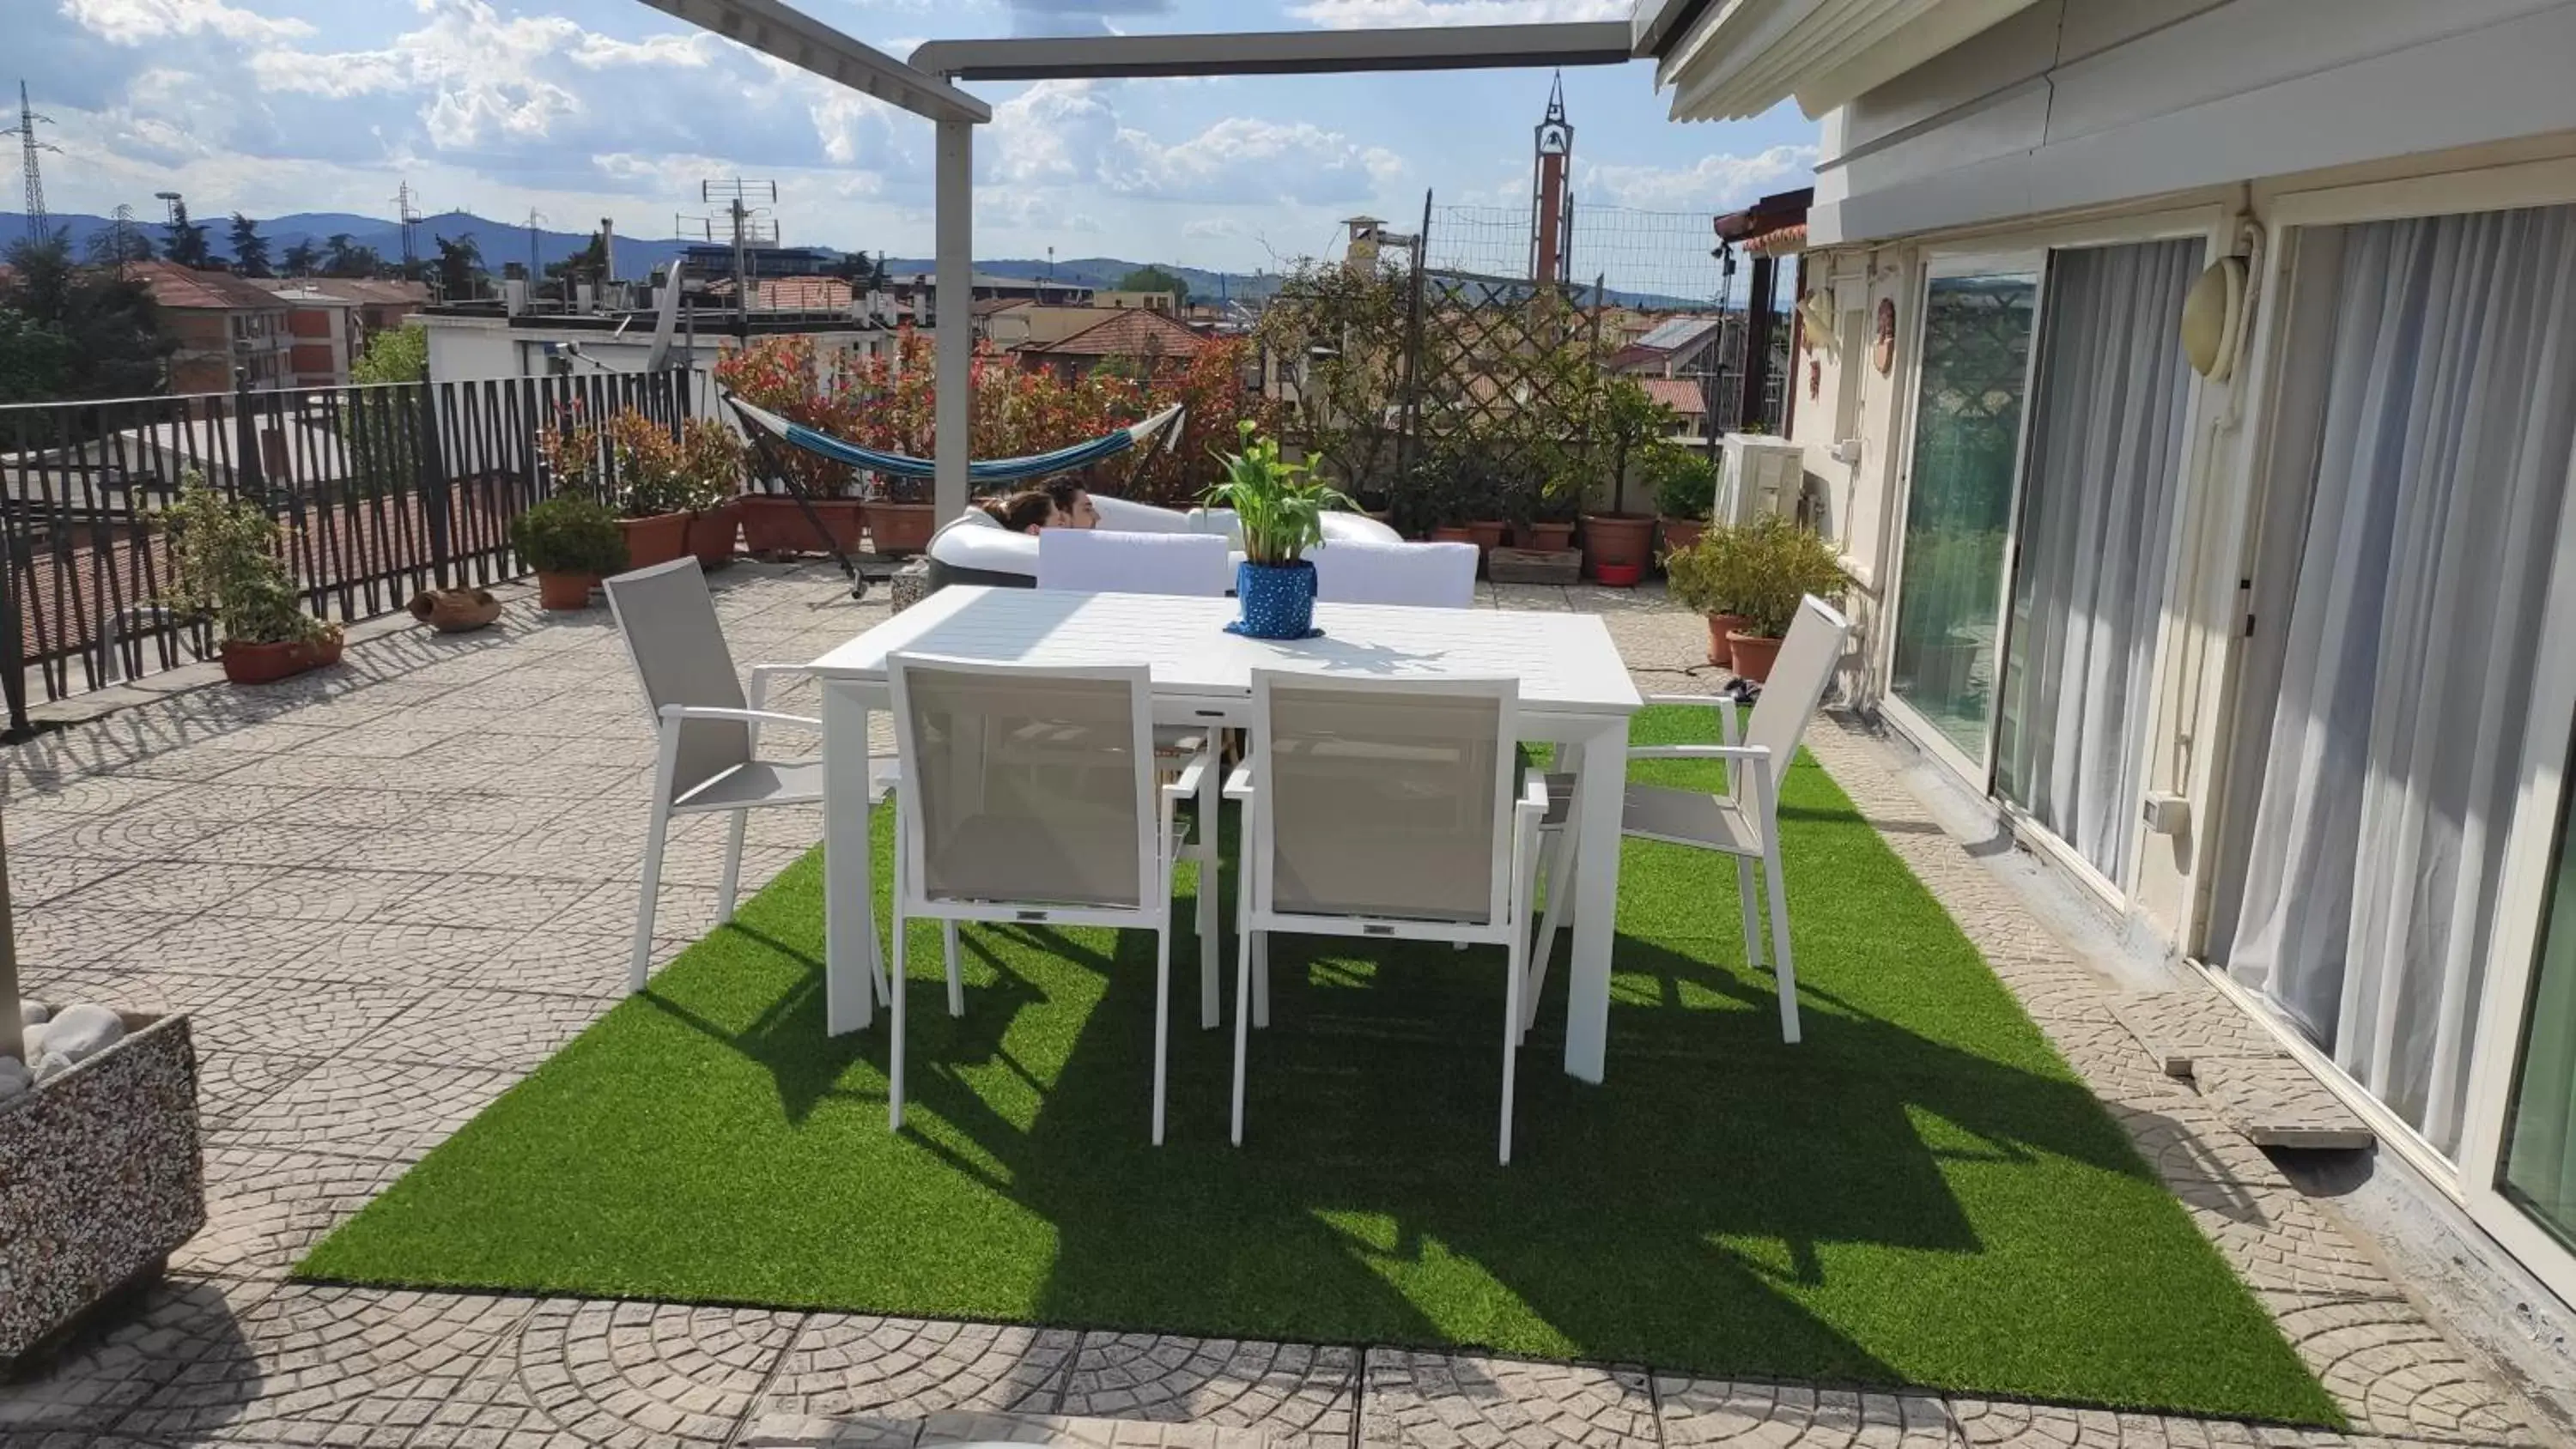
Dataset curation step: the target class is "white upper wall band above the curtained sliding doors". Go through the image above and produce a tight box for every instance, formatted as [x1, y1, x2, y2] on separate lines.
[1808, 0, 2576, 245]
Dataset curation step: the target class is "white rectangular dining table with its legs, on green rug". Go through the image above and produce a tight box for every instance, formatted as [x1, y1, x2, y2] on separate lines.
[811, 585, 1643, 1081]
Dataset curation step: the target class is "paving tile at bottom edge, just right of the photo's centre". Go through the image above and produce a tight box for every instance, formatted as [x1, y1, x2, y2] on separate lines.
[1360, 1349, 1659, 1449]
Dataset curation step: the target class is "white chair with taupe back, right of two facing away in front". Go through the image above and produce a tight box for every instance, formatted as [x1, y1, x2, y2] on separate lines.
[1226, 670, 1548, 1163]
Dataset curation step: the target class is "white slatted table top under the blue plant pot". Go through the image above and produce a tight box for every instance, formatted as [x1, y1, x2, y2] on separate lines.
[811, 585, 1643, 716]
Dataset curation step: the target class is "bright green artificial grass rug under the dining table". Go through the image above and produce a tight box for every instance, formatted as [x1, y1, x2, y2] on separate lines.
[299, 711, 2339, 1423]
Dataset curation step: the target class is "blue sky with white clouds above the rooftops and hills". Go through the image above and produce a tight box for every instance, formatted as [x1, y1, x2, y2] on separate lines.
[20, 0, 1816, 287]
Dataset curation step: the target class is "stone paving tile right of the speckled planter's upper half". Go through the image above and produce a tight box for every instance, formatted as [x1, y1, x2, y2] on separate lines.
[206, 1058, 518, 1163]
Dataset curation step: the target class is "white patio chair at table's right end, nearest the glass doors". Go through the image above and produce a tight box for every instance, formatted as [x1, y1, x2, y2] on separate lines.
[1522, 595, 1852, 1042]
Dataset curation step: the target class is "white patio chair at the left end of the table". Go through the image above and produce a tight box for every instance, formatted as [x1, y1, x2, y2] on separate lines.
[605, 559, 894, 996]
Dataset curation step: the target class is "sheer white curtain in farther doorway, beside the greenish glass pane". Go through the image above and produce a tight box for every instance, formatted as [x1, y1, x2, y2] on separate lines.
[1994, 239, 2200, 882]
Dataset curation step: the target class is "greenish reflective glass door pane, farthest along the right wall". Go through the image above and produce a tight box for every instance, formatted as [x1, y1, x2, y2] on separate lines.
[1888, 269, 2040, 782]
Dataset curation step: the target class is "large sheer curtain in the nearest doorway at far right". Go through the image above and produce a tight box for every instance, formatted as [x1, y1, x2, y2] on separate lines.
[2228, 206, 2576, 1153]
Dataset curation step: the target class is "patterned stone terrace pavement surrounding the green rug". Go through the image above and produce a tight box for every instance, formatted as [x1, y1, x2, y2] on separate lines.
[0, 567, 2558, 1449]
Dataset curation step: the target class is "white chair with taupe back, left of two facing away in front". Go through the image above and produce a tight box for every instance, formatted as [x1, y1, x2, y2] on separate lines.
[886, 654, 1211, 1145]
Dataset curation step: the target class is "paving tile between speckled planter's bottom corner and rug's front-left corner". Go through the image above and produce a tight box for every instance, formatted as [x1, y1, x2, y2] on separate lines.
[170, 1145, 407, 1279]
